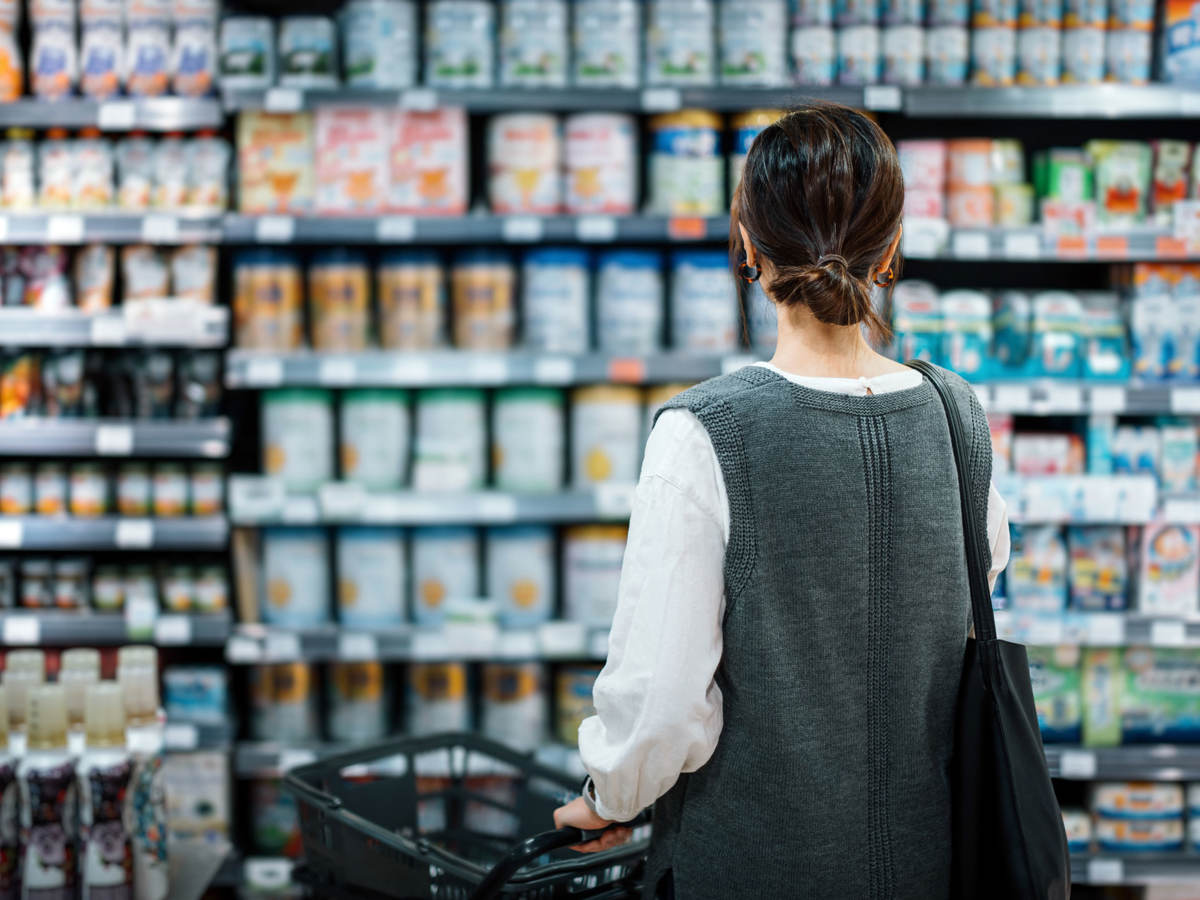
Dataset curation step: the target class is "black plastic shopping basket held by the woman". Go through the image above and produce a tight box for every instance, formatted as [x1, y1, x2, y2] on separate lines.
[284, 734, 649, 900]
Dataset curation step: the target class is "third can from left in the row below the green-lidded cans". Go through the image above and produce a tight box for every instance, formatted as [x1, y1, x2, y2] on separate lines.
[413, 527, 479, 625]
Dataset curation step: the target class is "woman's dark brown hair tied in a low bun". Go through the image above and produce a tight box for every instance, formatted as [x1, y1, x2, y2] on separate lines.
[730, 103, 904, 336]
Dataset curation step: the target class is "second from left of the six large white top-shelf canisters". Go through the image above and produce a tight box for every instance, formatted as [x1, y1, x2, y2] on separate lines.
[425, 0, 496, 88]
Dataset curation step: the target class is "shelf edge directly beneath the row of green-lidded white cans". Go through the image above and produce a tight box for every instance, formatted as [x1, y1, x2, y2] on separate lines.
[228, 475, 634, 526]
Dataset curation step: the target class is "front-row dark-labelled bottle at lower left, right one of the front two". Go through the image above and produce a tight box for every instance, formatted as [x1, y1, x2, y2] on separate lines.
[76, 682, 133, 900]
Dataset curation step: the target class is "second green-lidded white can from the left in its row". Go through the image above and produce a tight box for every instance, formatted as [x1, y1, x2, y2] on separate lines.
[340, 389, 410, 491]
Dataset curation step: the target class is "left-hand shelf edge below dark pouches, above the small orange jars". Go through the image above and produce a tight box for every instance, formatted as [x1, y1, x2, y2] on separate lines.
[0, 419, 230, 460]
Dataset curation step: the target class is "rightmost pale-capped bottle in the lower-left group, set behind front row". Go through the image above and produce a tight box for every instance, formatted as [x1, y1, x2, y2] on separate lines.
[116, 647, 168, 900]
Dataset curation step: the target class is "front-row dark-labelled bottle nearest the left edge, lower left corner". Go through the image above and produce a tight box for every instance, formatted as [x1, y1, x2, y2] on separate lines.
[17, 684, 76, 900]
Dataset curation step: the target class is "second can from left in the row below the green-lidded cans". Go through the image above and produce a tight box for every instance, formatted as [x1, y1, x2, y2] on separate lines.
[337, 528, 408, 628]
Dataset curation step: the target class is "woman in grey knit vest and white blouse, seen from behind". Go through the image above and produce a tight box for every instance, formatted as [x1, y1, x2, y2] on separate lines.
[554, 106, 1009, 900]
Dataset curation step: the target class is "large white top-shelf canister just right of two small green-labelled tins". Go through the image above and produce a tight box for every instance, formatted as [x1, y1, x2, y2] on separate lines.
[338, 0, 418, 88]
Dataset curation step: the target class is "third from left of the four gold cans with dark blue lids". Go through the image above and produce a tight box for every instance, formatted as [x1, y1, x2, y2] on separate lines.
[376, 252, 446, 350]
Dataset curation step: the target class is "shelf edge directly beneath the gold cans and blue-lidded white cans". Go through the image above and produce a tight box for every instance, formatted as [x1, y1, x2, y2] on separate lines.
[226, 350, 734, 395]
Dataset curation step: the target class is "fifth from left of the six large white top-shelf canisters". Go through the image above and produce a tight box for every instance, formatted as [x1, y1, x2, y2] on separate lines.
[646, 0, 715, 85]
